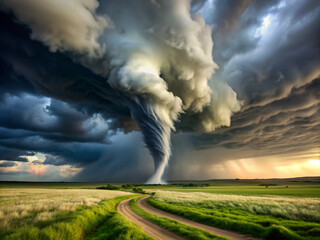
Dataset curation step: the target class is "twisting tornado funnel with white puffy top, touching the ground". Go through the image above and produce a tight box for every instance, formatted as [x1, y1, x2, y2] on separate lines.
[109, 60, 183, 184]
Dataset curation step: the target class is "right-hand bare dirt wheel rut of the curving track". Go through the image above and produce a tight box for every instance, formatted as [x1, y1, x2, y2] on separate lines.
[138, 195, 255, 240]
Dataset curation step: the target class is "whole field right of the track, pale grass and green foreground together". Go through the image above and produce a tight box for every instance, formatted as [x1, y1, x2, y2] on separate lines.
[149, 191, 320, 240]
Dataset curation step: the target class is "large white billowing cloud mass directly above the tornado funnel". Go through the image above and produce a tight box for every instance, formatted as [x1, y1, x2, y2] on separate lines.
[106, 1, 240, 131]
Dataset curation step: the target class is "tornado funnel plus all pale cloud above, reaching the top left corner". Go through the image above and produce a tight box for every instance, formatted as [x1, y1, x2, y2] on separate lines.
[0, 0, 241, 184]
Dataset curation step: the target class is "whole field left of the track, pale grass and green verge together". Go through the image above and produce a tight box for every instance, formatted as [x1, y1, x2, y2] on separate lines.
[0, 188, 150, 240]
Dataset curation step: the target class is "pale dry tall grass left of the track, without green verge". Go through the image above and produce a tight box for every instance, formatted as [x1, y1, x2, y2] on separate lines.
[0, 189, 129, 230]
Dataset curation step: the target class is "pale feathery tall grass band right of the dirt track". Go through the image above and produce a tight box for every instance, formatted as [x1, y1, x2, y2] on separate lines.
[154, 191, 320, 222]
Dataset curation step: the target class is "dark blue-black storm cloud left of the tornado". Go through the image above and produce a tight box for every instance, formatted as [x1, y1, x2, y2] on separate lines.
[0, 10, 138, 169]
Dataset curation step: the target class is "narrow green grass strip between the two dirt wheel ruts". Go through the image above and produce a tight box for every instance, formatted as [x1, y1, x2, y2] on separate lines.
[130, 196, 228, 240]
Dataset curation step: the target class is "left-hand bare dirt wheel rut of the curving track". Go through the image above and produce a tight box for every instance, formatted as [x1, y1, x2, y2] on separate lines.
[117, 198, 184, 240]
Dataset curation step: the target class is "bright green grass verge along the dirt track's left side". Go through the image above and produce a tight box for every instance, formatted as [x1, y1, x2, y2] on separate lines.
[1, 195, 150, 240]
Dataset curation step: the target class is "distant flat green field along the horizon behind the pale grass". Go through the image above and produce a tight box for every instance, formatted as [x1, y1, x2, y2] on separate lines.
[0, 178, 320, 198]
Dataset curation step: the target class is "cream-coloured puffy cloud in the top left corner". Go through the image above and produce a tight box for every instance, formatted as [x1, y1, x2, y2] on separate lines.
[0, 0, 111, 57]
